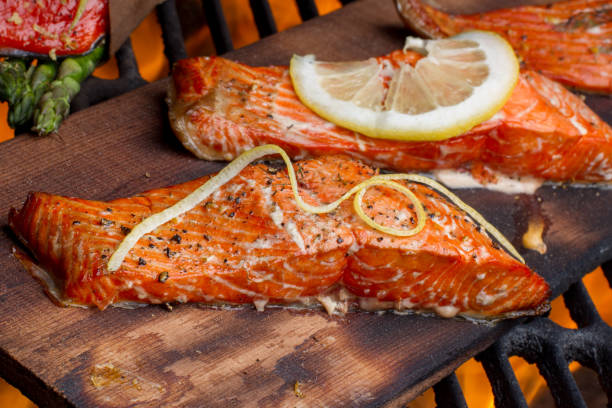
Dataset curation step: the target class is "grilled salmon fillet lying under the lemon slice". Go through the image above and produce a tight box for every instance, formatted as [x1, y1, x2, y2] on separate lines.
[167, 51, 612, 182]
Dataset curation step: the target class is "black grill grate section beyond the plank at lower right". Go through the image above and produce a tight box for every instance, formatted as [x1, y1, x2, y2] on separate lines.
[433, 261, 612, 408]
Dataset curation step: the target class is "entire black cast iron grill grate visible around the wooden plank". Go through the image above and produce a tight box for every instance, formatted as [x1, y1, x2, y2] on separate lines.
[5, 0, 612, 407]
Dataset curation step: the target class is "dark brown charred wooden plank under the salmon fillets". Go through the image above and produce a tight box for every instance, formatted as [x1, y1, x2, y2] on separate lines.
[0, 0, 612, 407]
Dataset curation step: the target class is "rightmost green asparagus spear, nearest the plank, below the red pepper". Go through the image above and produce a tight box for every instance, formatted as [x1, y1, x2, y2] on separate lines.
[32, 44, 104, 135]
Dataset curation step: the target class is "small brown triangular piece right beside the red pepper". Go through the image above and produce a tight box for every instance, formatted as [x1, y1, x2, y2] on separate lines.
[108, 0, 164, 55]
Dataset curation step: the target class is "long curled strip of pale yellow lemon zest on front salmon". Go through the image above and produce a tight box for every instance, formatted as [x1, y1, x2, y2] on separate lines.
[107, 145, 525, 273]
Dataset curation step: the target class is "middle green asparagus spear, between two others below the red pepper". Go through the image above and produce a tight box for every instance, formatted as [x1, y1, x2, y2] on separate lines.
[8, 62, 57, 128]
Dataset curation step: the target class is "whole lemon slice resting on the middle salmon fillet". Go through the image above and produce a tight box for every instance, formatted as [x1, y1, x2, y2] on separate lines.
[290, 31, 519, 141]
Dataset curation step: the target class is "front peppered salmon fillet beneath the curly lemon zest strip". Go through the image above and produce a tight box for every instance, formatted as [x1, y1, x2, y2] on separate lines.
[9, 156, 549, 318]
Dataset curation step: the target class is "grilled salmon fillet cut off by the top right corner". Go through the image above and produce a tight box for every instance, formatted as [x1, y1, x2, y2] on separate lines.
[395, 0, 612, 94]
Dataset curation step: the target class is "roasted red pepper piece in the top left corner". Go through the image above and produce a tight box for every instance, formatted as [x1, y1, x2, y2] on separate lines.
[0, 0, 109, 59]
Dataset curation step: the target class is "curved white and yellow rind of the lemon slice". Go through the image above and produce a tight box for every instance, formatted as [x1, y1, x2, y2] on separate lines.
[290, 31, 519, 141]
